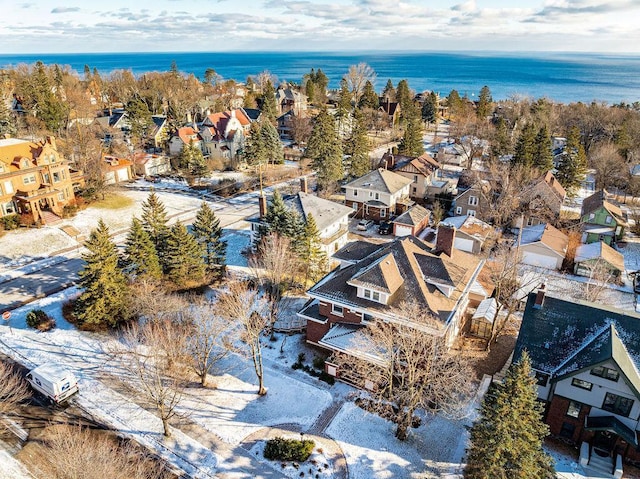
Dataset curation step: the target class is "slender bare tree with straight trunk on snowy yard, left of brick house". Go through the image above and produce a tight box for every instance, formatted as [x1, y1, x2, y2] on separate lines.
[216, 282, 269, 396]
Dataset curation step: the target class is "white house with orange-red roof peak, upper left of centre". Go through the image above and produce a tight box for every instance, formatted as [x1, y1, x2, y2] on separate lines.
[199, 108, 251, 160]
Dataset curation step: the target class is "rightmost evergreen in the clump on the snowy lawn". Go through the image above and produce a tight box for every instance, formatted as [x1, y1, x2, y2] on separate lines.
[192, 202, 227, 280]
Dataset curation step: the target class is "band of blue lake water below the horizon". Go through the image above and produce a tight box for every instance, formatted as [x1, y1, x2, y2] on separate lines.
[0, 52, 640, 104]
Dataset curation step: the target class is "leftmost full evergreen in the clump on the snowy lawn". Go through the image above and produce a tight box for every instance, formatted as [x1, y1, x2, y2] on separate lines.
[74, 220, 129, 326]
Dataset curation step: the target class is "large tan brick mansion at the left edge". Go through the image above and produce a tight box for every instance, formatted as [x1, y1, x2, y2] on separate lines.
[0, 136, 84, 223]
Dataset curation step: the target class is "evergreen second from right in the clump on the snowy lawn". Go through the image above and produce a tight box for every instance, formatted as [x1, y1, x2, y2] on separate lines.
[164, 223, 205, 288]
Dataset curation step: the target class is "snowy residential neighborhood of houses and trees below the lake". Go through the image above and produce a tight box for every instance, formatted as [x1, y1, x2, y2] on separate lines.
[0, 54, 640, 479]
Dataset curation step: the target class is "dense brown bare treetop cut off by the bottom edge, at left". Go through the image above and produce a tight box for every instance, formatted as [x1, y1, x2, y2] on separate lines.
[38, 424, 170, 479]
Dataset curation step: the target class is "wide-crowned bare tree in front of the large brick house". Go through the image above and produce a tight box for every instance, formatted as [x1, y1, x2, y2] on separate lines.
[338, 307, 473, 440]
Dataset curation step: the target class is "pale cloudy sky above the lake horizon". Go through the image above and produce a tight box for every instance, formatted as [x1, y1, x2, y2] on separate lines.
[0, 0, 640, 54]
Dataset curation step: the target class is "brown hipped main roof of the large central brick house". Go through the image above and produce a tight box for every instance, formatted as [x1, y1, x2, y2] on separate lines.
[309, 236, 481, 324]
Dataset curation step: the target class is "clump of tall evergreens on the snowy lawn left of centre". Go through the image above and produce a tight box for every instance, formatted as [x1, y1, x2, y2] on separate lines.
[74, 192, 227, 326]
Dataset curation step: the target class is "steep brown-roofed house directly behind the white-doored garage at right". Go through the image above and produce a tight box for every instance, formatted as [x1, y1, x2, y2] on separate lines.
[514, 171, 567, 228]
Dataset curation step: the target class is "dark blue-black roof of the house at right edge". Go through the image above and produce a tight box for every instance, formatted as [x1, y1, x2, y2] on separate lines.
[514, 293, 640, 378]
